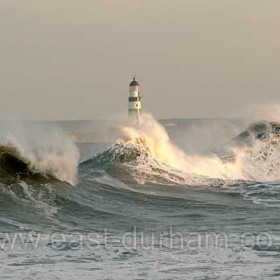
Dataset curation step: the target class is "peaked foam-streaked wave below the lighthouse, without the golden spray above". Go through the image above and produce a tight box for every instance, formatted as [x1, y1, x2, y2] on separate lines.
[80, 139, 228, 187]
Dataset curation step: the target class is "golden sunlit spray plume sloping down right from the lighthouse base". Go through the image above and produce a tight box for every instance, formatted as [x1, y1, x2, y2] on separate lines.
[122, 114, 238, 179]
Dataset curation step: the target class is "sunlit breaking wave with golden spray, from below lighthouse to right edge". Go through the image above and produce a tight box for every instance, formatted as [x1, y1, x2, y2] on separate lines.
[81, 115, 280, 186]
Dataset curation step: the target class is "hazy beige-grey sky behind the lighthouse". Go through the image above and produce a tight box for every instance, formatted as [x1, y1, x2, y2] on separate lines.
[0, 0, 280, 120]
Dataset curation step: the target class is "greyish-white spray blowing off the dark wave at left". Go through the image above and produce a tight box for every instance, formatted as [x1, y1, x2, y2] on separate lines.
[0, 121, 79, 185]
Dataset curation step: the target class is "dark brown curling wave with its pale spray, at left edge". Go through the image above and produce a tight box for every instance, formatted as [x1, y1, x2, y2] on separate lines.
[0, 123, 79, 185]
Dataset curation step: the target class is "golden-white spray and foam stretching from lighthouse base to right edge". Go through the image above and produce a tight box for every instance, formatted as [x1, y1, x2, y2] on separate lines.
[123, 114, 280, 181]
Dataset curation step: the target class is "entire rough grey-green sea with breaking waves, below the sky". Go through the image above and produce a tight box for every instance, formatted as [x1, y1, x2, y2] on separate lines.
[0, 115, 280, 280]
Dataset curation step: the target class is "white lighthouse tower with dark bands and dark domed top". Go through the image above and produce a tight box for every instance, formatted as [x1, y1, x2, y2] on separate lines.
[128, 77, 142, 124]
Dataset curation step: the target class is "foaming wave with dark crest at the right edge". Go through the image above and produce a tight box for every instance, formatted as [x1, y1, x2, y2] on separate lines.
[218, 122, 280, 182]
